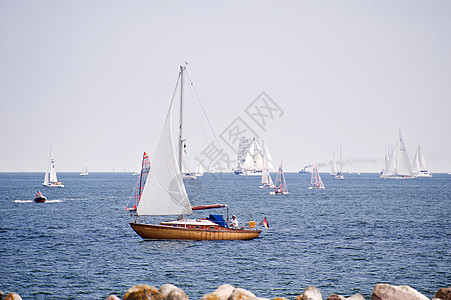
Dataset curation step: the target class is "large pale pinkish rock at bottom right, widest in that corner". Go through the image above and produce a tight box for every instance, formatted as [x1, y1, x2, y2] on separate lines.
[371, 284, 429, 300]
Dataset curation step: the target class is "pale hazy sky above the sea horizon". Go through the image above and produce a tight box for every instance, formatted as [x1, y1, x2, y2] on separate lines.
[0, 0, 451, 173]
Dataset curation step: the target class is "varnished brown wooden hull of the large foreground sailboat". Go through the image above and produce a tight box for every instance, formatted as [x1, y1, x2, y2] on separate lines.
[130, 223, 261, 240]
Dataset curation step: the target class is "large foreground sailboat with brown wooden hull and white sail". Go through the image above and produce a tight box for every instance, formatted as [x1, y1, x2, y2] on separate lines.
[130, 66, 261, 240]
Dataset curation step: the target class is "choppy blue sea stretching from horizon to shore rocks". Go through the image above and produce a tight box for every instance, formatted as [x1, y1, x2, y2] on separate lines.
[0, 173, 451, 299]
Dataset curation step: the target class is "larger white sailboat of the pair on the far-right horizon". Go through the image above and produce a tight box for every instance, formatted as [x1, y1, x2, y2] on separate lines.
[381, 129, 416, 179]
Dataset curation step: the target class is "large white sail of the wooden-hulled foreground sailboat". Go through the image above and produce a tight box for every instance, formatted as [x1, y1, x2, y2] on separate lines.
[137, 67, 192, 215]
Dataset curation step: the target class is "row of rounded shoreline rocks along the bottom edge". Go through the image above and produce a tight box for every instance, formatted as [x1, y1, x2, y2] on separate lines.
[0, 284, 451, 300]
